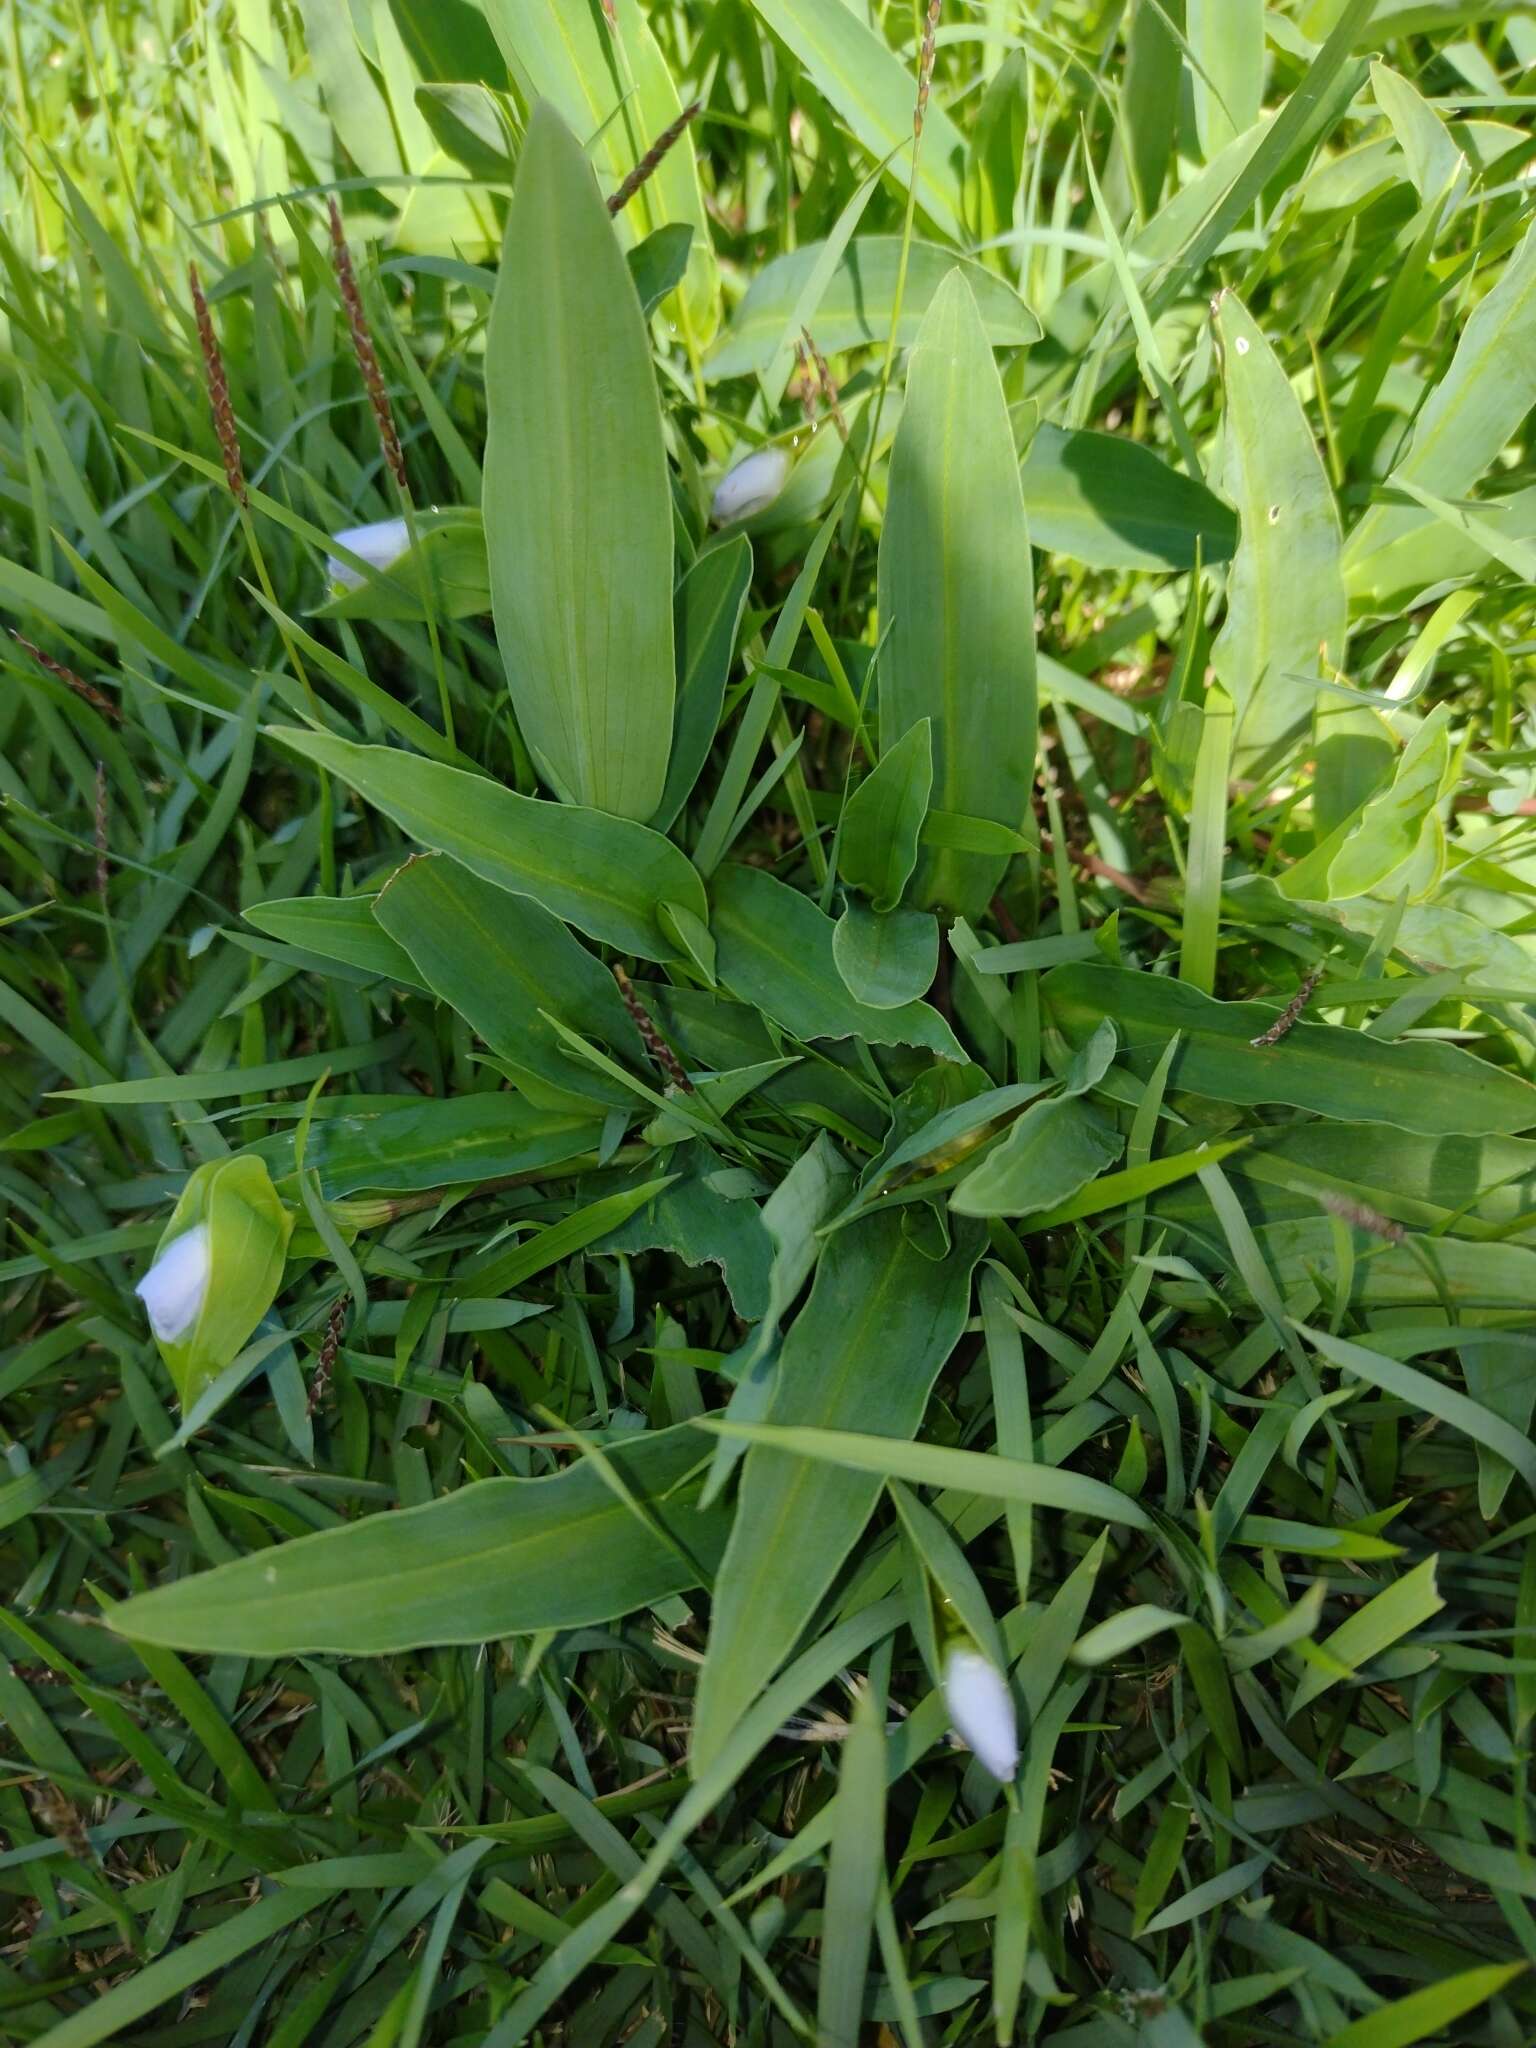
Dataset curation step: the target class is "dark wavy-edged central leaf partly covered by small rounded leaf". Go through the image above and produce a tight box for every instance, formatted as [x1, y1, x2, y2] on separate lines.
[713, 864, 965, 1059]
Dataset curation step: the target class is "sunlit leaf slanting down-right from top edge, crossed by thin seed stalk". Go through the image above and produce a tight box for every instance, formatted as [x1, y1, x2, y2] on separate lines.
[752, 0, 965, 240]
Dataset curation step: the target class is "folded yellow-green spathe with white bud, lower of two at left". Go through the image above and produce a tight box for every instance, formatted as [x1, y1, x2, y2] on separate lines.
[135, 1157, 293, 1407]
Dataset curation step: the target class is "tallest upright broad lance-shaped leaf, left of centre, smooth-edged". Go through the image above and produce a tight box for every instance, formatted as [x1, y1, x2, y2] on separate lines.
[483, 102, 676, 819]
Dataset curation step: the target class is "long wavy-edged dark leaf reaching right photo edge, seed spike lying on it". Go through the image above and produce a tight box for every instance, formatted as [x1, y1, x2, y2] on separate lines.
[1042, 963, 1536, 1137]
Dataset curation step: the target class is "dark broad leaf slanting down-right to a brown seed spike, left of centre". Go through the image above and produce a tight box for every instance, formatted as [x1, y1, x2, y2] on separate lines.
[373, 854, 645, 1110]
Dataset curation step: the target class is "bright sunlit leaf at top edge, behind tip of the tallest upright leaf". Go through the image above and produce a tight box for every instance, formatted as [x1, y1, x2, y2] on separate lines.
[483, 0, 721, 344]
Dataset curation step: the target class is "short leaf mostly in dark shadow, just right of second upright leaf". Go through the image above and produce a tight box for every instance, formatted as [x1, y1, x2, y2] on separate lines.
[1024, 420, 1237, 569]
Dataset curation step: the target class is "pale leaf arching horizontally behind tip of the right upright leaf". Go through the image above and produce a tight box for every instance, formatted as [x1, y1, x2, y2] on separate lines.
[705, 236, 1040, 381]
